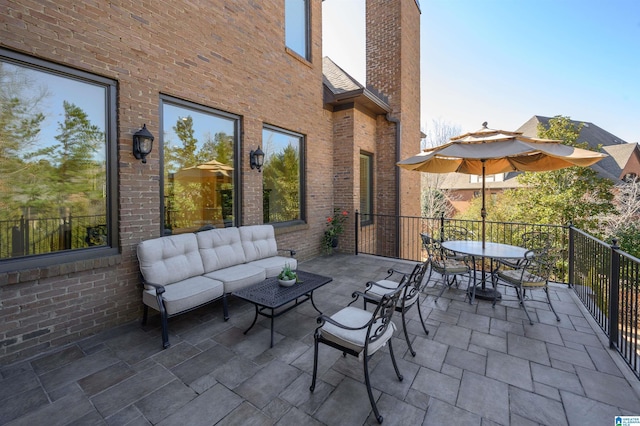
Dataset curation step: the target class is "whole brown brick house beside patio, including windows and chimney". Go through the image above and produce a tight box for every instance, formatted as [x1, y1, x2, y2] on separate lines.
[0, 0, 420, 363]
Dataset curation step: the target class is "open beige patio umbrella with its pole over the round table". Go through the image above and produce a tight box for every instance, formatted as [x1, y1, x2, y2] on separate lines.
[397, 122, 607, 247]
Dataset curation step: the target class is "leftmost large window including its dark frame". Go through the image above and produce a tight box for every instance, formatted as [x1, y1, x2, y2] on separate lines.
[0, 49, 117, 270]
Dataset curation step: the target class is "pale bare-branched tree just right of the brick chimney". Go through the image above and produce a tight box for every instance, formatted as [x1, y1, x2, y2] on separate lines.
[420, 119, 461, 217]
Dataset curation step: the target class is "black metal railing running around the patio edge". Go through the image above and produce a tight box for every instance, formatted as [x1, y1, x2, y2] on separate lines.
[355, 212, 640, 378]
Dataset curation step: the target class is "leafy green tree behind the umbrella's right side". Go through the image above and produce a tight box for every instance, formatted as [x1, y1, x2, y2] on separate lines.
[492, 116, 613, 232]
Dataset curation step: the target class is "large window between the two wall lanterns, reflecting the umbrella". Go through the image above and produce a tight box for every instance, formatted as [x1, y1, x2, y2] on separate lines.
[162, 97, 240, 234]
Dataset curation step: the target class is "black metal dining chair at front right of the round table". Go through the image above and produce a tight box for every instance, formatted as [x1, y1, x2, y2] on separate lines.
[491, 250, 560, 325]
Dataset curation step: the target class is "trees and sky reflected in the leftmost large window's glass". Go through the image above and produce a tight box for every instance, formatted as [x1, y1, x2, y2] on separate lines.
[0, 62, 106, 259]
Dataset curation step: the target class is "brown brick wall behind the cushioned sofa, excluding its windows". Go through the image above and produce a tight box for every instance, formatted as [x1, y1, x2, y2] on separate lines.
[0, 0, 333, 363]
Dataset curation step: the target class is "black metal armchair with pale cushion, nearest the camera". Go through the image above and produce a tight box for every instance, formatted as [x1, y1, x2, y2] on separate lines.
[309, 279, 406, 423]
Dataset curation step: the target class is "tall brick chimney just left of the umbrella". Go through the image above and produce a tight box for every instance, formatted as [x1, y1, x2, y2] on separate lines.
[366, 0, 421, 220]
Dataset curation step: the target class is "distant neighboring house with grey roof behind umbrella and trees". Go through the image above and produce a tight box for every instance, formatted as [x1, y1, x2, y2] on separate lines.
[440, 115, 640, 212]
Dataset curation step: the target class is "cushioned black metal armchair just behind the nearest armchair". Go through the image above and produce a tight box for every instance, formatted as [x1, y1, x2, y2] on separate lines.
[364, 259, 429, 356]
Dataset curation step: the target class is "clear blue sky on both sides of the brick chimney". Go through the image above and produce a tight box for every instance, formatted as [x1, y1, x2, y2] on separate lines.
[322, 0, 640, 142]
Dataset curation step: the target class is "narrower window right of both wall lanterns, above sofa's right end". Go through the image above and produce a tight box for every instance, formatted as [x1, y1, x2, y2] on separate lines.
[262, 126, 304, 223]
